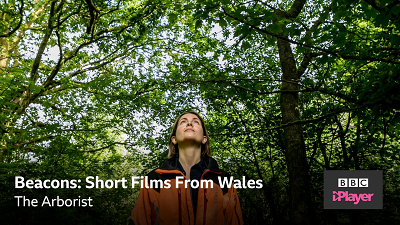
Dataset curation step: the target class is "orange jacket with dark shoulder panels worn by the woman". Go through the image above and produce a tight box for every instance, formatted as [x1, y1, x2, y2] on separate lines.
[130, 157, 243, 225]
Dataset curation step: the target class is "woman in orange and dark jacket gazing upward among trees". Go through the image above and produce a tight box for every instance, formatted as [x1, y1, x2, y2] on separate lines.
[130, 112, 243, 225]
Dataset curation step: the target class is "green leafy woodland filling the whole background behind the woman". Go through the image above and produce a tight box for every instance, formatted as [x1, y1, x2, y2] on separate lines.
[0, 0, 400, 224]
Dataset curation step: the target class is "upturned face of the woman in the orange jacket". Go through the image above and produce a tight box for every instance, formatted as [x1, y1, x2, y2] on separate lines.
[171, 113, 207, 145]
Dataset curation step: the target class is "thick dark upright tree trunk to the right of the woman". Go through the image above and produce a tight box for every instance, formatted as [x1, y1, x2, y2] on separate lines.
[278, 35, 311, 224]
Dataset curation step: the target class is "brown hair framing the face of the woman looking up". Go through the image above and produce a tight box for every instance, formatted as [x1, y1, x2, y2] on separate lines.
[168, 111, 211, 159]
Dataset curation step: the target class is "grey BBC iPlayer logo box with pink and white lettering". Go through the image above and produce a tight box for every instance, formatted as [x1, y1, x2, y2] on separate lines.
[324, 170, 383, 209]
